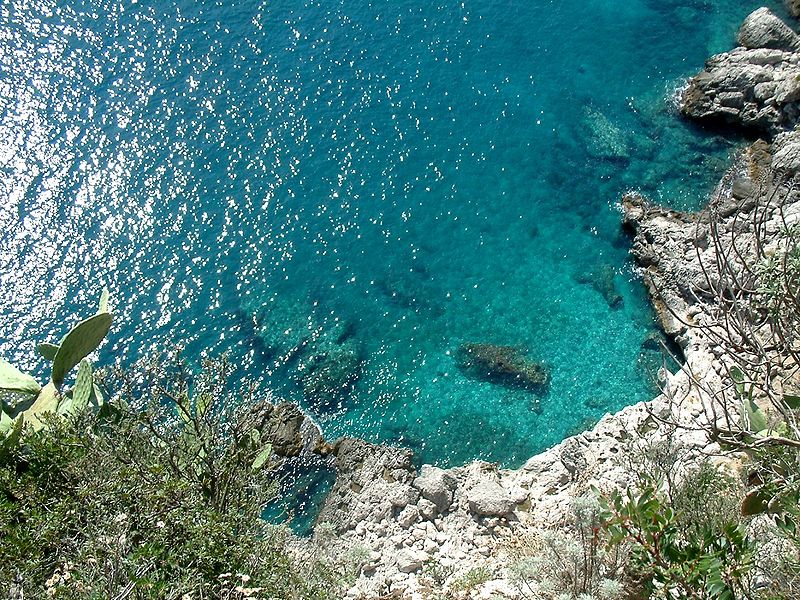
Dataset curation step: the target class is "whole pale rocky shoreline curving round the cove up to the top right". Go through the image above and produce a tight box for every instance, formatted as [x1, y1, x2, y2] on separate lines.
[268, 2, 800, 599]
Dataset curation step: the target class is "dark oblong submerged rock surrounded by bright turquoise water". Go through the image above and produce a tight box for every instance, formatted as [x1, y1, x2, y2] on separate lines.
[456, 344, 549, 392]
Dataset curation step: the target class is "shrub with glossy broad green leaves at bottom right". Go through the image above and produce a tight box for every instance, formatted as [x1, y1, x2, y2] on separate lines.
[602, 483, 755, 600]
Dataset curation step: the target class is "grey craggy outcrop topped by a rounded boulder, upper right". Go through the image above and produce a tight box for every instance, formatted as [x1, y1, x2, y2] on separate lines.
[680, 8, 800, 135]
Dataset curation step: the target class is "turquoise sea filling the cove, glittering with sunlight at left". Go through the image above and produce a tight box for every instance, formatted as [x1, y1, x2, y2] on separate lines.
[0, 0, 781, 474]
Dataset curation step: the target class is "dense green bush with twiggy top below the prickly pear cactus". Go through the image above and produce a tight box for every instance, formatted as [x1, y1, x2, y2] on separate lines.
[0, 361, 341, 600]
